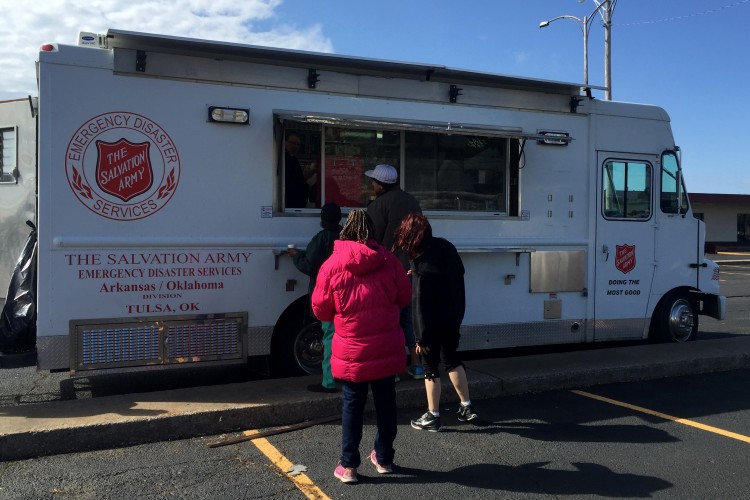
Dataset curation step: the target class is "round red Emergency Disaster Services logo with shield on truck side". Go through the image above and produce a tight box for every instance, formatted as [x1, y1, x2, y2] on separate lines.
[65, 111, 180, 221]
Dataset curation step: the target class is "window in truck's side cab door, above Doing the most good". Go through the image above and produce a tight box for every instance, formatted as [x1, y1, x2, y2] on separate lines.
[602, 160, 651, 220]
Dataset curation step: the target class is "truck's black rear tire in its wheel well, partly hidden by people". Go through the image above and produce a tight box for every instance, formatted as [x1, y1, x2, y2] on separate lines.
[271, 304, 323, 377]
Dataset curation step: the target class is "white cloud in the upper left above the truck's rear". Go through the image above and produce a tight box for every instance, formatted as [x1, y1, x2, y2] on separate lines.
[0, 0, 333, 100]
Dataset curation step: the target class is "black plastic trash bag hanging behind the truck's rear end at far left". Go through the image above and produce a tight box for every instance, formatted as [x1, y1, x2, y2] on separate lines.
[0, 221, 37, 354]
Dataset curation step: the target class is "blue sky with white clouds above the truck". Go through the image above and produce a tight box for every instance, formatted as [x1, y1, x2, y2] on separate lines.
[0, 0, 750, 194]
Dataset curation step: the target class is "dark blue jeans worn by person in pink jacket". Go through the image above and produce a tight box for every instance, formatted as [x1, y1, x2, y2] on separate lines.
[340, 376, 398, 468]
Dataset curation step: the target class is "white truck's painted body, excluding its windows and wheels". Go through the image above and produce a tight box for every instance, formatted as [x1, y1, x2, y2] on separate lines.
[30, 31, 718, 370]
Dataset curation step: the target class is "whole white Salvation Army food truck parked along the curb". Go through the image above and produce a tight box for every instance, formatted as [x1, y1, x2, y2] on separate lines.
[8, 30, 726, 373]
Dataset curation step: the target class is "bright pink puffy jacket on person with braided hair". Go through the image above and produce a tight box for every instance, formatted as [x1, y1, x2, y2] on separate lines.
[312, 240, 411, 382]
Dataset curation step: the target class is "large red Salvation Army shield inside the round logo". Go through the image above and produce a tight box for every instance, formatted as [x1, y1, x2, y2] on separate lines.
[96, 139, 154, 202]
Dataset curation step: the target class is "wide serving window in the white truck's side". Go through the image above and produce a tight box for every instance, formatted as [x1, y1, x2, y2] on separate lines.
[284, 121, 519, 215]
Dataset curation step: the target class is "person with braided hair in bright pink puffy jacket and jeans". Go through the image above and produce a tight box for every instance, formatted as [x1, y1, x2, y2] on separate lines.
[312, 210, 411, 483]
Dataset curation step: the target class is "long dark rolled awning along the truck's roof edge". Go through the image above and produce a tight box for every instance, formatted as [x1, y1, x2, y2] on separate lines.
[107, 30, 581, 95]
